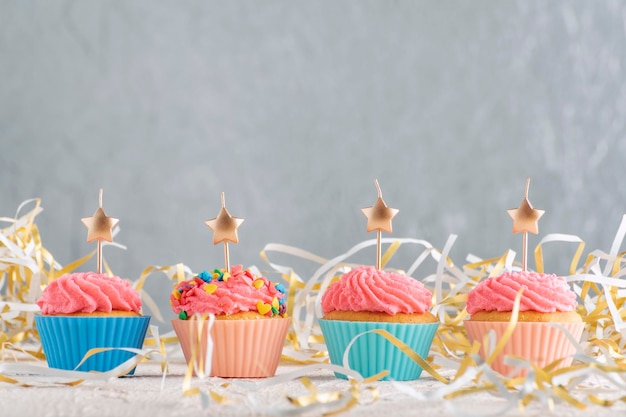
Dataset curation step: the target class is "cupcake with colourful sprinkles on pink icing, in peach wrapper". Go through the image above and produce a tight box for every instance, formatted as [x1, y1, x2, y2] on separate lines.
[170, 265, 289, 378]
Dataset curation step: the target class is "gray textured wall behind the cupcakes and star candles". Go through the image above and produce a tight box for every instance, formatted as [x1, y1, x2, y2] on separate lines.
[0, 0, 626, 306]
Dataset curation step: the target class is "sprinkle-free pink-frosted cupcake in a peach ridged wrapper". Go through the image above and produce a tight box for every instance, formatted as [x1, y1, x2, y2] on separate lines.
[464, 271, 584, 376]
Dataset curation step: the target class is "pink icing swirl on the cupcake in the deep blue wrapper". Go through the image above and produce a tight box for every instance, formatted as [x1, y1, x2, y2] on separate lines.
[37, 272, 141, 314]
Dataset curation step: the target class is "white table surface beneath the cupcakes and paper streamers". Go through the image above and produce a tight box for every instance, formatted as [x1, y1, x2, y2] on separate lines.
[0, 354, 626, 417]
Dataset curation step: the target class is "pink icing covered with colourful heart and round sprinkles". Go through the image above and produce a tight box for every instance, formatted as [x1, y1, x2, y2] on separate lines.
[170, 265, 286, 316]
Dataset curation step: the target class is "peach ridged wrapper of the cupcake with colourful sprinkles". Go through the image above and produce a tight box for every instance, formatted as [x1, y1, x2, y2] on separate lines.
[172, 318, 290, 378]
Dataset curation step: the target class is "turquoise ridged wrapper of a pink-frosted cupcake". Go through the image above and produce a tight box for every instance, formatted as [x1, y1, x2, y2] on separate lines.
[319, 320, 439, 381]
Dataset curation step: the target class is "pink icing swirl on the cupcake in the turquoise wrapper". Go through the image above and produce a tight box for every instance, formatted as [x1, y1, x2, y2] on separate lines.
[322, 266, 432, 314]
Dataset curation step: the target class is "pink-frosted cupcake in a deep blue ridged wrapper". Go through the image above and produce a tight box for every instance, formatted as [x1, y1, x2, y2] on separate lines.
[35, 272, 150, 374]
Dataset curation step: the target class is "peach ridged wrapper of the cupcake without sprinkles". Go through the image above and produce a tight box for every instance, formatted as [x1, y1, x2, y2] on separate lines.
[464, 320, 585, 376]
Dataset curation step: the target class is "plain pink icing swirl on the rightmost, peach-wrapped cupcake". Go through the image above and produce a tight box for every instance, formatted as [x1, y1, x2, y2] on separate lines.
[467, 271, 577, 314]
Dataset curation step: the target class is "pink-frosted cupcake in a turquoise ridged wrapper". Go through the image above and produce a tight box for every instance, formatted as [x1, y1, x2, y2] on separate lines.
[319, 266, 439, 381]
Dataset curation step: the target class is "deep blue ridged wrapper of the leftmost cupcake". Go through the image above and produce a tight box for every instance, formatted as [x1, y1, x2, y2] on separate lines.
[35, 316, 150, 375]
